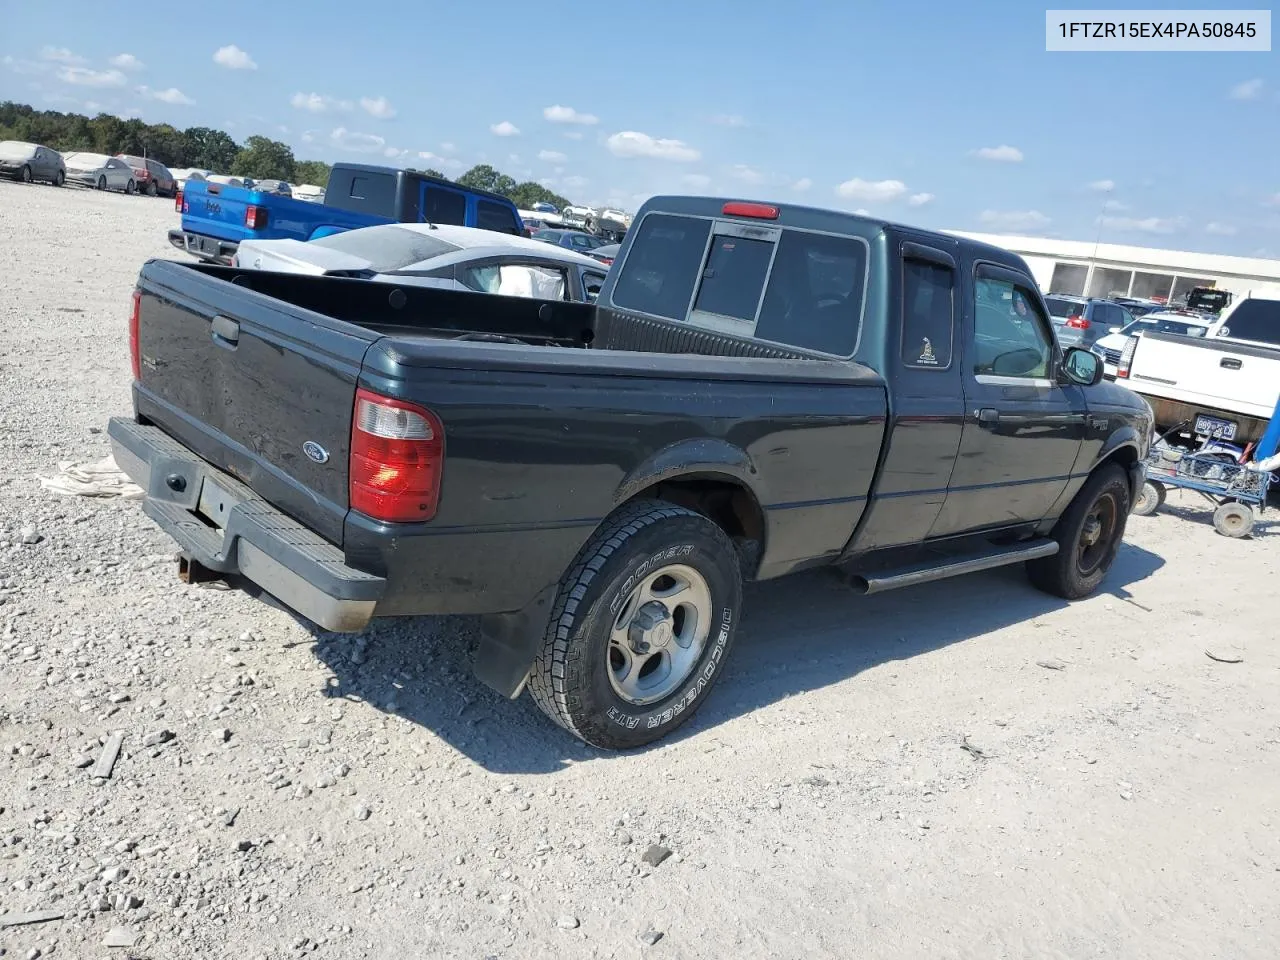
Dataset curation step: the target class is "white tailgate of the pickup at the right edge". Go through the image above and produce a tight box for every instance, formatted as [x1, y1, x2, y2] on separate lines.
[1121, 333, 1280, 420]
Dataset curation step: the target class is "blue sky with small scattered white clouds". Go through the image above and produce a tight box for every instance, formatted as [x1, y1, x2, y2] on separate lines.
[0, 0, 1280, 256]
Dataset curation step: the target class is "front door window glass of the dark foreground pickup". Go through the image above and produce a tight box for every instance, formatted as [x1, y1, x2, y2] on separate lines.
[973, 271, 1053, 379]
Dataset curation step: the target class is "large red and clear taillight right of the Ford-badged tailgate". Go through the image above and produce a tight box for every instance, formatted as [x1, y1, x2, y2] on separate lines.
[348, 389, 444, 524]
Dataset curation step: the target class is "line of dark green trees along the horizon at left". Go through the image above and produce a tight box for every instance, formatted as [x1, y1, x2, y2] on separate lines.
[0, 100, 570, 210]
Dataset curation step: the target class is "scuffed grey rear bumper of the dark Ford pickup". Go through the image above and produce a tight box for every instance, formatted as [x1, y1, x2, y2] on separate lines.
[108, 417, 387, 632]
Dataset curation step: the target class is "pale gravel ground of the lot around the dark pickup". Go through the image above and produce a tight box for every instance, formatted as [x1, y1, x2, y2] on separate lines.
[0, 183, 1280, 960]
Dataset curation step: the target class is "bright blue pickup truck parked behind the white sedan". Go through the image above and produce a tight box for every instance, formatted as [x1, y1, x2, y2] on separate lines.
[169, 164, 525, 264]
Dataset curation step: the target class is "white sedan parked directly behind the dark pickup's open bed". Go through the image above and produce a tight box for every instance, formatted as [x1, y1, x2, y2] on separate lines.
[232, 223, 608, 302]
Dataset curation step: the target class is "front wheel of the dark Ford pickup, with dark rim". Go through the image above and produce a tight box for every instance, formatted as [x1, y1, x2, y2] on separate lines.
[1027, 463, 1129, 600]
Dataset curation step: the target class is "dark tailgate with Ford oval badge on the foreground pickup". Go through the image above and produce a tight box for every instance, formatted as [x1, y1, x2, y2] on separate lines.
[134, 261, 379, 544]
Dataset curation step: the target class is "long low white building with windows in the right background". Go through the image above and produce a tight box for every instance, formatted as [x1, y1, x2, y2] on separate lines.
[951, 230, 1280, 300]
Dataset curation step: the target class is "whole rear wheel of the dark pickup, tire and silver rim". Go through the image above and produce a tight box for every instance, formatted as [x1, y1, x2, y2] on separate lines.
[529, 500, 742, 750]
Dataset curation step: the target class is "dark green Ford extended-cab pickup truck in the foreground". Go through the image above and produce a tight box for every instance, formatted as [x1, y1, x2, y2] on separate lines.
[109, 197, 1151, 748]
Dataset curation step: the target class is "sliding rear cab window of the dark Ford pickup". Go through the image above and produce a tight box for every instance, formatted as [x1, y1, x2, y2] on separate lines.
[613, 214, 868, 357]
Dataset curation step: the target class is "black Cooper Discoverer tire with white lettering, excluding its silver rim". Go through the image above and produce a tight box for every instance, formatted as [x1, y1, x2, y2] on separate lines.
[529, 500, 742, 750]
